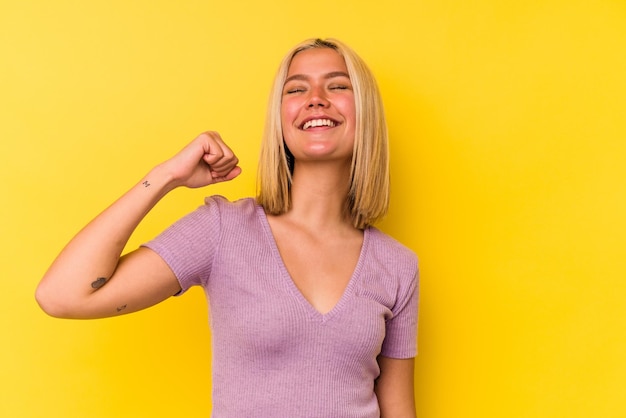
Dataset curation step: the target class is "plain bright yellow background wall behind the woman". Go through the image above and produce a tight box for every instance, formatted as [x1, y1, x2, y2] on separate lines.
[0, 0, 626, 418]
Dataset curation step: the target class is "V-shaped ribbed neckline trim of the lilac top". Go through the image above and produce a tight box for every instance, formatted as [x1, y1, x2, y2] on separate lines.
[256, 204, 370, 322]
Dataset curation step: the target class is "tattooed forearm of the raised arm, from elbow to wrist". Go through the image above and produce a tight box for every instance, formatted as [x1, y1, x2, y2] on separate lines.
[36, 166, 174, 316]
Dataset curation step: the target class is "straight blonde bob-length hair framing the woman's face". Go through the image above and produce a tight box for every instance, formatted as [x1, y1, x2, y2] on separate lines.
[257, 39, 389, 229]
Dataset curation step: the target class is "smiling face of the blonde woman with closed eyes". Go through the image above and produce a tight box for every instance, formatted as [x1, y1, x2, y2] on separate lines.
[281, 48, 356, 162]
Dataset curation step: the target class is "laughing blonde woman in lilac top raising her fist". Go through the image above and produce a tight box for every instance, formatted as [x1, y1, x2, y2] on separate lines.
[36, 39, 418, 418]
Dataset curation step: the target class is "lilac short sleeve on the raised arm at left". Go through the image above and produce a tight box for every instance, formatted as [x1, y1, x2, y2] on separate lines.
[143, 197, 221, 294]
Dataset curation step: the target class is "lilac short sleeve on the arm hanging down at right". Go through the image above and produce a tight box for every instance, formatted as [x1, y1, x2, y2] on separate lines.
[381, 260, 419, 359]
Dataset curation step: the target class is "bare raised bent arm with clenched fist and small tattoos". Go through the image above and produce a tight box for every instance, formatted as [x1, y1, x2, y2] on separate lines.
[35, 132, 241, 318]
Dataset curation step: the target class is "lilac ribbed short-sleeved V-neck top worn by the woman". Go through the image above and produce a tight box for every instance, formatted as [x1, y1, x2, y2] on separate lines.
[146, 196, 418, 418]
